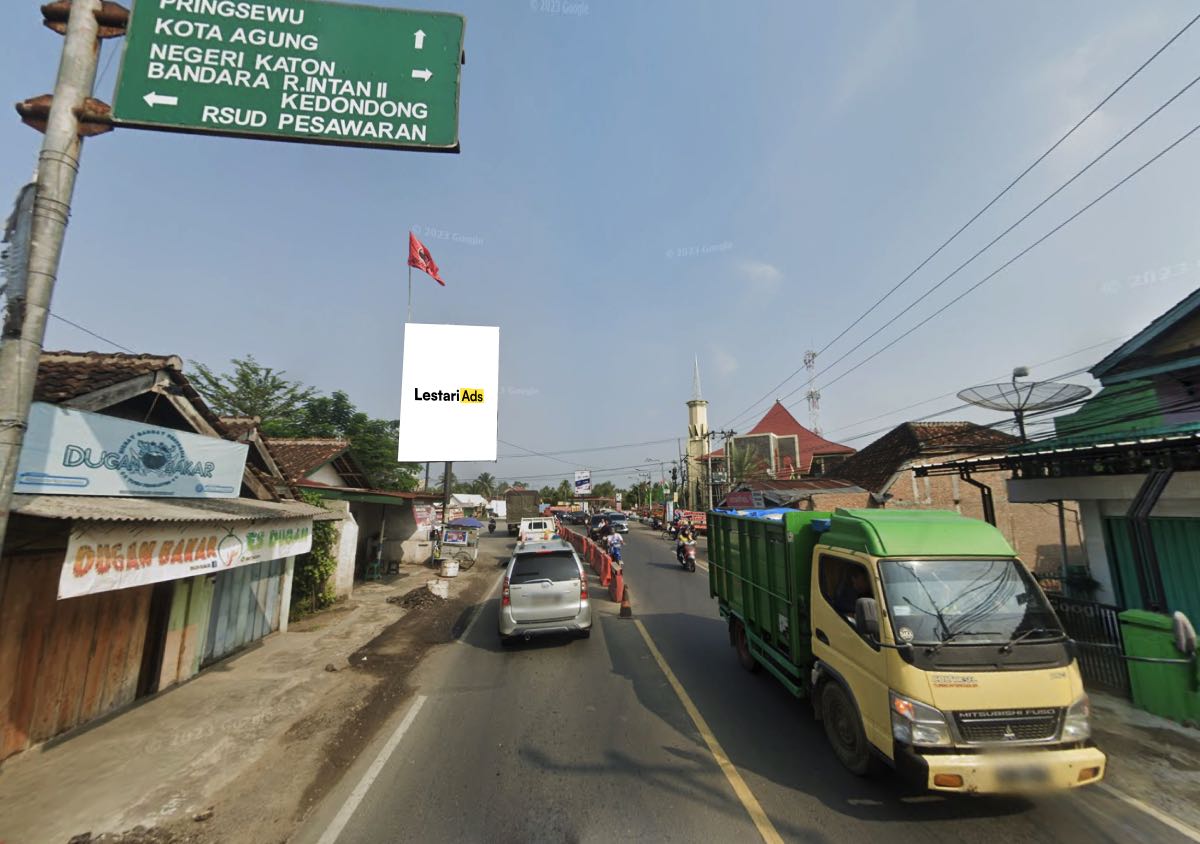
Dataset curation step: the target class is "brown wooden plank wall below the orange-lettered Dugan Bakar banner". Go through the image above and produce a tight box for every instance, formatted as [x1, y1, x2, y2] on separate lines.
[0, 553, 152, 759]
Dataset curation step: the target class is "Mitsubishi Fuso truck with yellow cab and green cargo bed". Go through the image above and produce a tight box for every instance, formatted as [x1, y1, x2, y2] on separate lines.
[709, 510, 1105, 794]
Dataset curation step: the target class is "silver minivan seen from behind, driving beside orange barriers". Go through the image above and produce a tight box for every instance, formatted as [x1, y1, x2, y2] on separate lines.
[499, 539, 592, 645]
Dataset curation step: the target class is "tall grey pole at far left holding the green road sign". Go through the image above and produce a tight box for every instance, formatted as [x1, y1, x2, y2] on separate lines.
[0, 0, 101, 557]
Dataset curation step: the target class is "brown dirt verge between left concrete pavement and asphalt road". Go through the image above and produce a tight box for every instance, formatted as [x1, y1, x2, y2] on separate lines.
[71, 567, 493, 844]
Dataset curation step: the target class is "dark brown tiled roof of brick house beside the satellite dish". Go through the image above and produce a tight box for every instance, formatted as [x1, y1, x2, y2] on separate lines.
[833, 421, 1018, 492]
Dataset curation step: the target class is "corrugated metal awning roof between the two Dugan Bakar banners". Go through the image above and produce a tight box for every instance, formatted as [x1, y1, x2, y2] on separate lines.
[12, 495, 329, 522]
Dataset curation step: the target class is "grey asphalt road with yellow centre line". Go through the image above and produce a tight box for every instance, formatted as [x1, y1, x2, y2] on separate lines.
[296, 526, 1188, 844]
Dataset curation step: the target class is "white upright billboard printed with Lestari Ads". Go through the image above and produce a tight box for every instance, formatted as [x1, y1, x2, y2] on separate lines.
[397, 323, 500, 463]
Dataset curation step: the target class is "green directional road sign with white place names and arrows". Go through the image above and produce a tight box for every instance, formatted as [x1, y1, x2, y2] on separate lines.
[113, 0, 466, 152]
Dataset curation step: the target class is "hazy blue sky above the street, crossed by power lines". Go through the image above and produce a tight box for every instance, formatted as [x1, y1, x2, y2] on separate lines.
[0, 0, 1200, 484]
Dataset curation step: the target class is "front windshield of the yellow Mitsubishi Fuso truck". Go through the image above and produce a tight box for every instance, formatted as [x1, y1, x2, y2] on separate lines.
[880, 559, 1066, 647]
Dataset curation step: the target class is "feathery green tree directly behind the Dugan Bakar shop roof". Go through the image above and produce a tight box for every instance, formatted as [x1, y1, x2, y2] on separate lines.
[191, 354, 317, 425]
